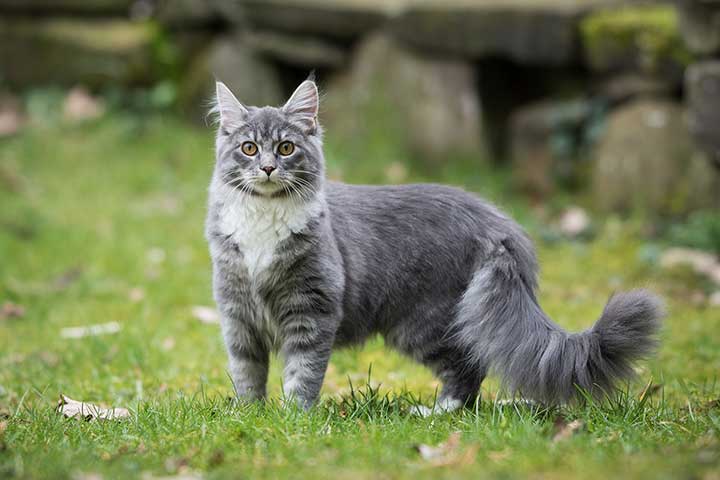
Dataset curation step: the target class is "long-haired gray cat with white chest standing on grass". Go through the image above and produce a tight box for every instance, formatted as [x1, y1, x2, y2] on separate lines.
[206, 80, 662, 413]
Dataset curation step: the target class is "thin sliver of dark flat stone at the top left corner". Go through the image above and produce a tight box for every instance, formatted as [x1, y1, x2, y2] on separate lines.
[0, 0, 138, 15]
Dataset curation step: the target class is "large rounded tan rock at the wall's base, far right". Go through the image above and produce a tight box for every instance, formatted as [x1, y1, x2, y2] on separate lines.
[593, 100, 720, 214]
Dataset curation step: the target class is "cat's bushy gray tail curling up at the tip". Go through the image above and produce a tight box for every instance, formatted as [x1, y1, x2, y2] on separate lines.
[454, 242, 663, 404]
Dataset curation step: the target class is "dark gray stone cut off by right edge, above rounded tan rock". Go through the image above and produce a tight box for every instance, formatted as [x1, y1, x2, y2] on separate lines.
[685, 60, 720, 168]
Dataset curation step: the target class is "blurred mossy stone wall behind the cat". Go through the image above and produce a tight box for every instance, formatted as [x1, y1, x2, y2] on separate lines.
[0, 0, 720, 213]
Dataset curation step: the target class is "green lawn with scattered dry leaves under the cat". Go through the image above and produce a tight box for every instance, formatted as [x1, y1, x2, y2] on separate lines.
[0, 115, 720, 479]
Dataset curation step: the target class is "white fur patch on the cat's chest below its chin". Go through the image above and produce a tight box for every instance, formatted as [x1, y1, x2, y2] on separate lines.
[216, 182, 322, 278]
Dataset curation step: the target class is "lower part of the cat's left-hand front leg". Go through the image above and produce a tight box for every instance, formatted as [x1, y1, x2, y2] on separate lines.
[221, 315, 270, 401]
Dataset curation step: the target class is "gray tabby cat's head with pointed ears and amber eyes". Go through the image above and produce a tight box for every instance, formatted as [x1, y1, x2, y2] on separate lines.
[213, 80, 324, 201]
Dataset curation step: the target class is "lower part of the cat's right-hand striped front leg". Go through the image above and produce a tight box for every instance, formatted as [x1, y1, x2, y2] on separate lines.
[281, 314, 336, 410]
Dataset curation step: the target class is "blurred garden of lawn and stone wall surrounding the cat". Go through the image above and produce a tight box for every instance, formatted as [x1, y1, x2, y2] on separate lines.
[0, 0, 720, 480]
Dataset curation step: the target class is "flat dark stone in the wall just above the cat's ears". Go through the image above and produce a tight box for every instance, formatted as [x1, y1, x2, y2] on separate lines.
[243, 31, 347, 69]
